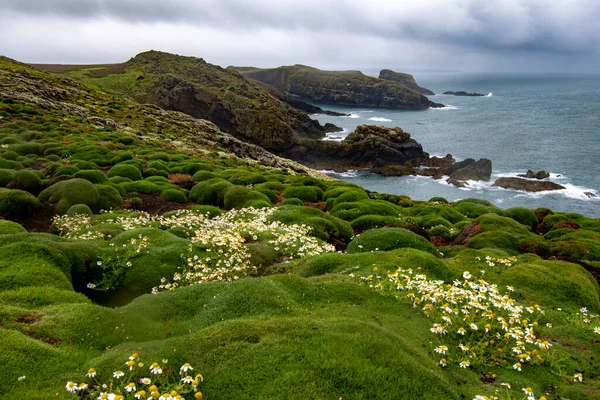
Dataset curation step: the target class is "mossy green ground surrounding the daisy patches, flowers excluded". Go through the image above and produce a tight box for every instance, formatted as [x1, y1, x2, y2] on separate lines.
[0, 59, 600, 399]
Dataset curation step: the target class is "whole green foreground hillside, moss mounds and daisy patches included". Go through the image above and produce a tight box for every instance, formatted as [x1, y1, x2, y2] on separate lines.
[0, 54, 600, 400]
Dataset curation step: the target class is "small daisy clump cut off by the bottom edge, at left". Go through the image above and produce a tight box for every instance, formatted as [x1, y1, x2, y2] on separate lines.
[65, 353, 204, 400]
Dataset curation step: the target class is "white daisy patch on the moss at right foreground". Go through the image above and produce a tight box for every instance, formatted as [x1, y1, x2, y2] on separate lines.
[359, 268, 552, 371]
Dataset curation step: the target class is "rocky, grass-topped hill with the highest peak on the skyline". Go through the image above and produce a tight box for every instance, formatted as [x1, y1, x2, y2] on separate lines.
[34, 51, 324, 150]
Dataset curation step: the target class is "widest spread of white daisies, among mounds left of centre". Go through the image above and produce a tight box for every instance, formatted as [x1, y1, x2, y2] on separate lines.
[54, 208, 335, 293]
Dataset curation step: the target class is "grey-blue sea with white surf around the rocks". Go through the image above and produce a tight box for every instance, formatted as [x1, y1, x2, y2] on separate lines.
[313, 73, 600, 217]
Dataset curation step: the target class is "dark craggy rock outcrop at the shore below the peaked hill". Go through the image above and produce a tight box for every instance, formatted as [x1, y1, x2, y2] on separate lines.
[285, 125, 428, 175]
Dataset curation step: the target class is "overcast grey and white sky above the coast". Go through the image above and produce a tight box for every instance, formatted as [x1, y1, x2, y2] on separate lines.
[0, 0, 600, 72]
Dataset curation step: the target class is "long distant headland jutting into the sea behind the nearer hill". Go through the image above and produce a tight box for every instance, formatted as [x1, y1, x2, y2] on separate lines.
[229, 65, 443, 109]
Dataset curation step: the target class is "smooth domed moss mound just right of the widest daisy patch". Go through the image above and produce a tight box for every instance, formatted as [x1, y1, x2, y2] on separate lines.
[348, 228, 440, 257]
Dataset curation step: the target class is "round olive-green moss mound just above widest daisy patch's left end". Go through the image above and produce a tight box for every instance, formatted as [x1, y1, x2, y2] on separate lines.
[38, 178, 100, 213]
